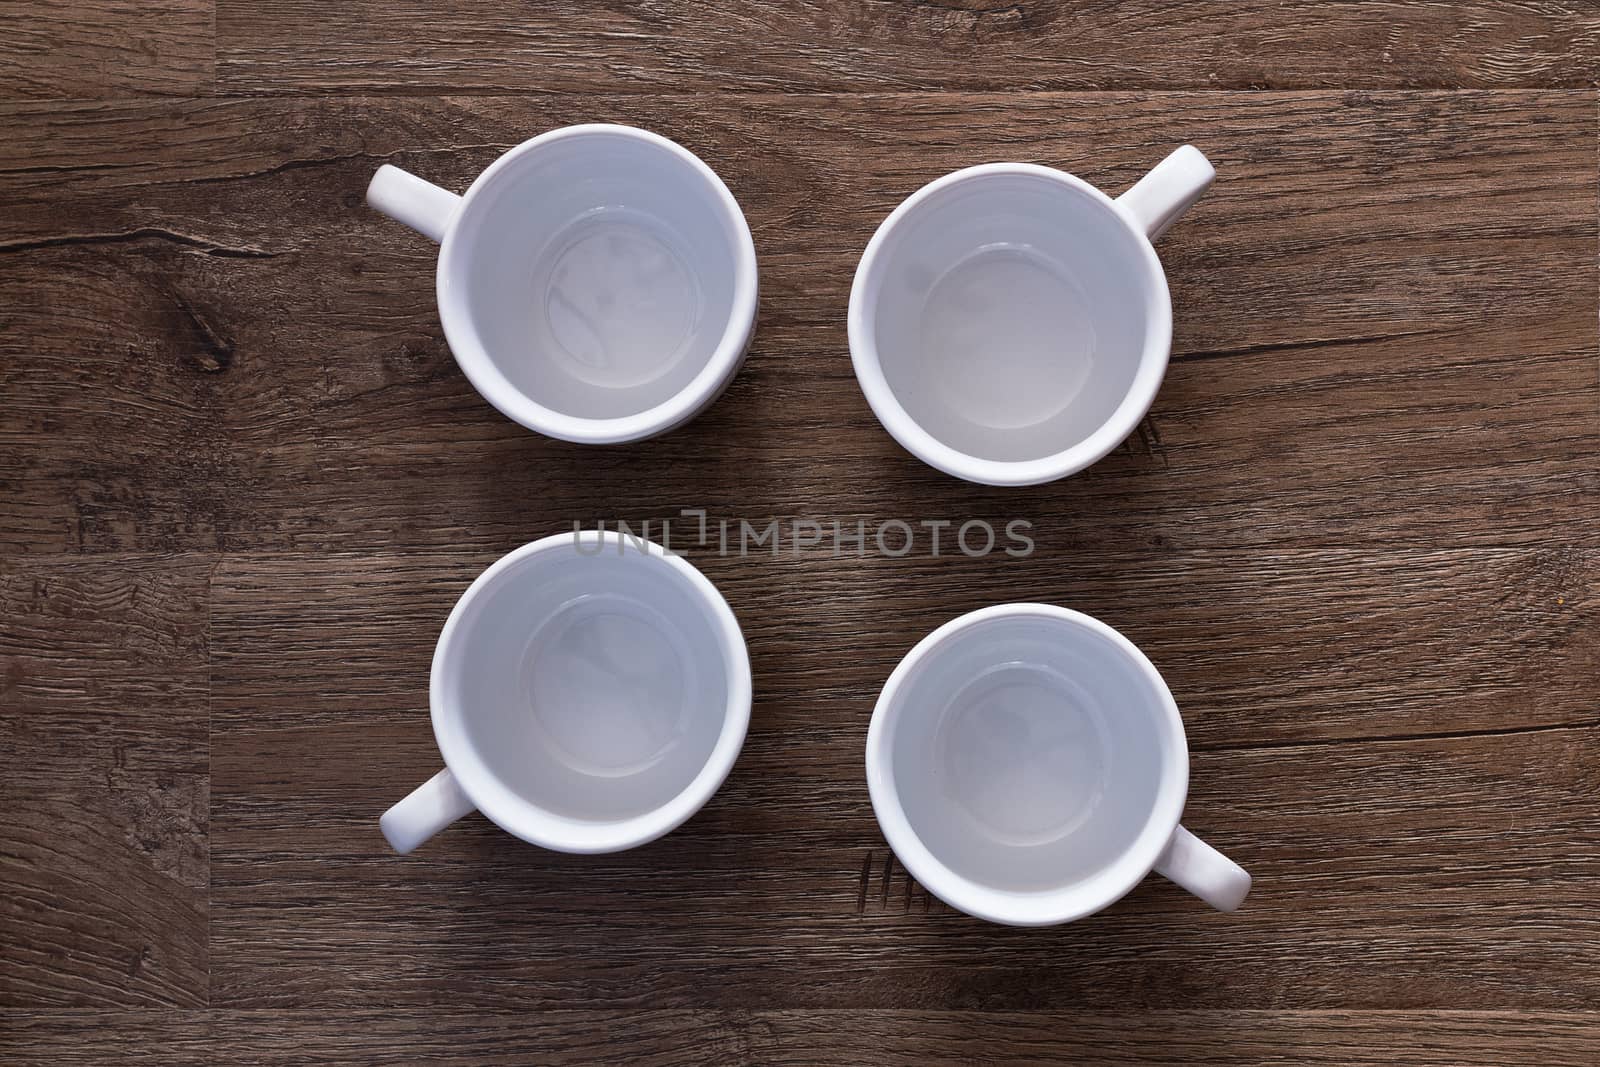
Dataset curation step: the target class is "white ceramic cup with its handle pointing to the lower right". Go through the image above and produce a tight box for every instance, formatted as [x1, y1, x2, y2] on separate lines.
[867, 603, 1250, 926]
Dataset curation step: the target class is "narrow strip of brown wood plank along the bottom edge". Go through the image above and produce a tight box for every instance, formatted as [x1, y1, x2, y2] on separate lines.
[0, 1009, 1600, 1067]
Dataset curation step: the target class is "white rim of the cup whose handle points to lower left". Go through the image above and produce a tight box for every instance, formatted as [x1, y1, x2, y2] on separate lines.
[429, 530, 752, 854]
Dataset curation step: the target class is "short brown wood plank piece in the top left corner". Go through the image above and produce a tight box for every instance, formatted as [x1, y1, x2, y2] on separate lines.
[0, 0, 216, 99]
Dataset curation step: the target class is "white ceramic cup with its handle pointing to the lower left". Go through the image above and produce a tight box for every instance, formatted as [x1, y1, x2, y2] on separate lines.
[379, 530, 750, 853]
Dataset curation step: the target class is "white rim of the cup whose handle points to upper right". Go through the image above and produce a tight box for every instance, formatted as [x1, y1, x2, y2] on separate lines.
[848, 163, 1173, 486]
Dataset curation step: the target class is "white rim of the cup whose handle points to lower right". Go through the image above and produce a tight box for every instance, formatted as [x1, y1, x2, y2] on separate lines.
[866, 603, 1189, 926]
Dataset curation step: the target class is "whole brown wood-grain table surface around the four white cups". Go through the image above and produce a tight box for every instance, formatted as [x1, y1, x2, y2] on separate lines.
[0, 0, 1600, 1067]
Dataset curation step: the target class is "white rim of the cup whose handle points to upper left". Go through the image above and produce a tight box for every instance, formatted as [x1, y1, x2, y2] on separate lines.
[435, 123, 758, 445]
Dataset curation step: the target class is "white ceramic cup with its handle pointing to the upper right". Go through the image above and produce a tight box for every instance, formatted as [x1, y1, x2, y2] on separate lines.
[850, 146, 1216, 485]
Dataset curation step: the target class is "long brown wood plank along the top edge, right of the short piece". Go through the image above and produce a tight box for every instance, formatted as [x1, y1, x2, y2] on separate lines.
[218, 0, 1600, 93]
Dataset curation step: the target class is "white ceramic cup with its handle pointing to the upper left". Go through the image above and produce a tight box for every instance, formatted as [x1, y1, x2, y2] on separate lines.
[366, 125, 757, 445]
